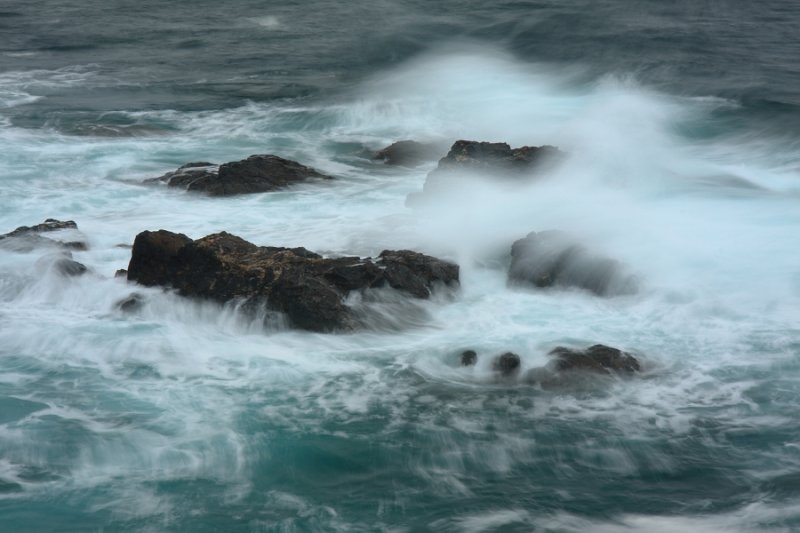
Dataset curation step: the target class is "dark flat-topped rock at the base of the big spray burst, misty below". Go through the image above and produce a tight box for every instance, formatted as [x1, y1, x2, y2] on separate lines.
[407, 140, 563, 205]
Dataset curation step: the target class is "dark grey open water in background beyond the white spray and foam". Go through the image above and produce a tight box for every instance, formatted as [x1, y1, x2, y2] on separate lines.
[0, 0, 800, 127]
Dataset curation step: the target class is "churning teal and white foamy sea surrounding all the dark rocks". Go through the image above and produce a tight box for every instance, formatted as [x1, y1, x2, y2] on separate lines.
[0, 0, 800, 533]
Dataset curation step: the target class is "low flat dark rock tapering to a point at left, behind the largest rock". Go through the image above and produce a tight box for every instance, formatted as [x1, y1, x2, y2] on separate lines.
[145, 155, 333, 196]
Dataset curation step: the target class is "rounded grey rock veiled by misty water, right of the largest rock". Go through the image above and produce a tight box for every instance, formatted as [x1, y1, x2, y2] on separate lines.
[508, 231, 637, 296]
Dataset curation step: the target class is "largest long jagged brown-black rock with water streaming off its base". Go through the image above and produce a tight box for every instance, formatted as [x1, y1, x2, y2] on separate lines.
[128, 230, 458, 331]
